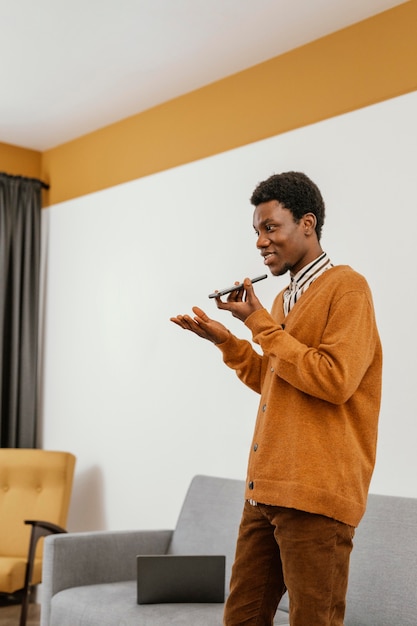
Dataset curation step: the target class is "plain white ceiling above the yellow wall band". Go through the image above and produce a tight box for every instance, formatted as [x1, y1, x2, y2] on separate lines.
[0, 0, 403, 151]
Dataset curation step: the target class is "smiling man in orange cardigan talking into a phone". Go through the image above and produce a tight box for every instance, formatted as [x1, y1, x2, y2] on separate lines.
[172, 172, 382, 626]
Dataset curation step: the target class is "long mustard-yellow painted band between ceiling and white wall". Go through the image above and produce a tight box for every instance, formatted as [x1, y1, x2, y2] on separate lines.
[0, 0, 417, 204]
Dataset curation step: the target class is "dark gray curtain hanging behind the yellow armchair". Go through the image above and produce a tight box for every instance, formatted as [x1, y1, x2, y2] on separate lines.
[0, 173, 43, 448]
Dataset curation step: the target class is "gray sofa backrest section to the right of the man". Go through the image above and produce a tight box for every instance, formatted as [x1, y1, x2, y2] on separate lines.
[345, 495, 417, 626]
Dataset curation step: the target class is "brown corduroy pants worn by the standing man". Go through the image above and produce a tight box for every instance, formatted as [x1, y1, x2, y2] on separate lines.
[224, 502, 354, 626]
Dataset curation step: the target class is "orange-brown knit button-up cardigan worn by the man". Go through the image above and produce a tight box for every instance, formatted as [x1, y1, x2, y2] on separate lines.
[218, 266, 382, 526]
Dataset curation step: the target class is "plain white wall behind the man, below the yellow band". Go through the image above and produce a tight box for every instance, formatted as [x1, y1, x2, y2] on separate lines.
[41, 93, 417, 530]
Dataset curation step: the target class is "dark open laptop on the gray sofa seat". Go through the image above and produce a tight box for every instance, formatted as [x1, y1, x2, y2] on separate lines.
[137, 554, 226, 604]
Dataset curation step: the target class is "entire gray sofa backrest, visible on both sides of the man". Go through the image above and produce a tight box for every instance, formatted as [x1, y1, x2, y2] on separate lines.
[168, 476, 417, 626]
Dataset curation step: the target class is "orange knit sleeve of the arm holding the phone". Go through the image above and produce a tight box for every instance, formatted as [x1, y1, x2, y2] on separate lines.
[246, 289, 379, 404]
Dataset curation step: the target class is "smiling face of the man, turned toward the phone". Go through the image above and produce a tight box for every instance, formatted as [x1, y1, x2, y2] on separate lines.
[253, 200, 320, 276]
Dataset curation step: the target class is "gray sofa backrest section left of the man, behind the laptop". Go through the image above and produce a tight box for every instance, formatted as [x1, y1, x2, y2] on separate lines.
[168, 476, 245, 589]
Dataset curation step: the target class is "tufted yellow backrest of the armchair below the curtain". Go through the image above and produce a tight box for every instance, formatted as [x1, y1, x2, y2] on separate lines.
[0, 448, 75, 559]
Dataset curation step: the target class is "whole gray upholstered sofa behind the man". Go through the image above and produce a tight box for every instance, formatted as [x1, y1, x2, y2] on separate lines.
[41, 476, 417, 626]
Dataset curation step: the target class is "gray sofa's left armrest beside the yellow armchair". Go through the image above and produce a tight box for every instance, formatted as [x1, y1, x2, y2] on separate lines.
[42, 530, 173, 605]
